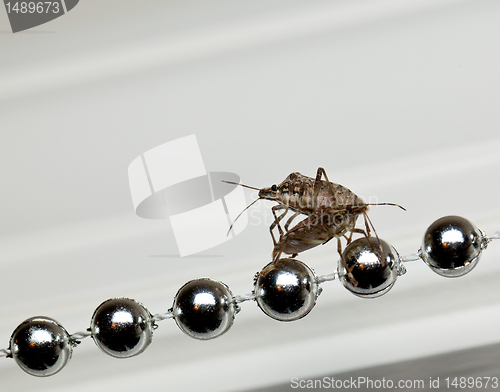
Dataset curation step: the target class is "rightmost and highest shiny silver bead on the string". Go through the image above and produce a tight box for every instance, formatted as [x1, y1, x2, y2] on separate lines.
[419, 215, 487, 278]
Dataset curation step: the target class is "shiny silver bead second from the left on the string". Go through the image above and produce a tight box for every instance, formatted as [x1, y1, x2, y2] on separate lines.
[90, 298, 153, 358]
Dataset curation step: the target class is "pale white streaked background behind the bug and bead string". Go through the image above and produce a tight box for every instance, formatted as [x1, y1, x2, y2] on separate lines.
[0, 0, 500, 391]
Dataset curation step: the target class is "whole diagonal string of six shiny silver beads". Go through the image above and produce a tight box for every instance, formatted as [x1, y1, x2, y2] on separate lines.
[0, 216, 500, 377]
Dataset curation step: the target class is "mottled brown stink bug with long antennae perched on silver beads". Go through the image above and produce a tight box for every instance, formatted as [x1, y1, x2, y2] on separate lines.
[226, 167, 404, 272]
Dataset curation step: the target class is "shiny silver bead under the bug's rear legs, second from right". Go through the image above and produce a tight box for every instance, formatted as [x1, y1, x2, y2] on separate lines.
[338, 237, 400, 298]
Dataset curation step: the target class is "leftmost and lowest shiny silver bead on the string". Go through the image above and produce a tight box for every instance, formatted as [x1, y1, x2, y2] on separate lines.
[10, 316, 73, 377]
